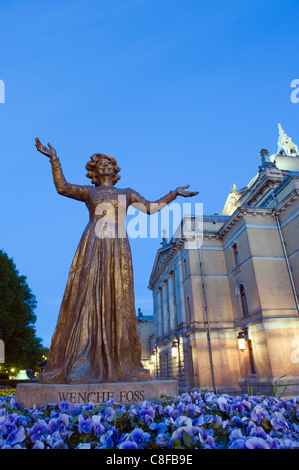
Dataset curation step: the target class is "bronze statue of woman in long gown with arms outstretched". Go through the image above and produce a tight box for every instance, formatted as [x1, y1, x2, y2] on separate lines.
[36, 139, 198, 383]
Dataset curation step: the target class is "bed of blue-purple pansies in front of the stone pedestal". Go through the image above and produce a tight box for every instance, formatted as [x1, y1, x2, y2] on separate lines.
[0, 391, 299, 449]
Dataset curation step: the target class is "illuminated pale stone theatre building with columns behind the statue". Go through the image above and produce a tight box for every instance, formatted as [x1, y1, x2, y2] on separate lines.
[149, 125, 299, 396]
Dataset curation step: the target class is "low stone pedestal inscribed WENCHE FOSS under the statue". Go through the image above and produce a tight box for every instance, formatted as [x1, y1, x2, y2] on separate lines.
[15, 380, 178, 408]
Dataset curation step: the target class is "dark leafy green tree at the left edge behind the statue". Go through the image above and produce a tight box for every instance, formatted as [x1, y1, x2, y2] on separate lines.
[0, 250, 43, 370]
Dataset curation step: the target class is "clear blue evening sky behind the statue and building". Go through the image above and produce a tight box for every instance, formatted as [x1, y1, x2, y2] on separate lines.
[0, 0, 299, 346]
